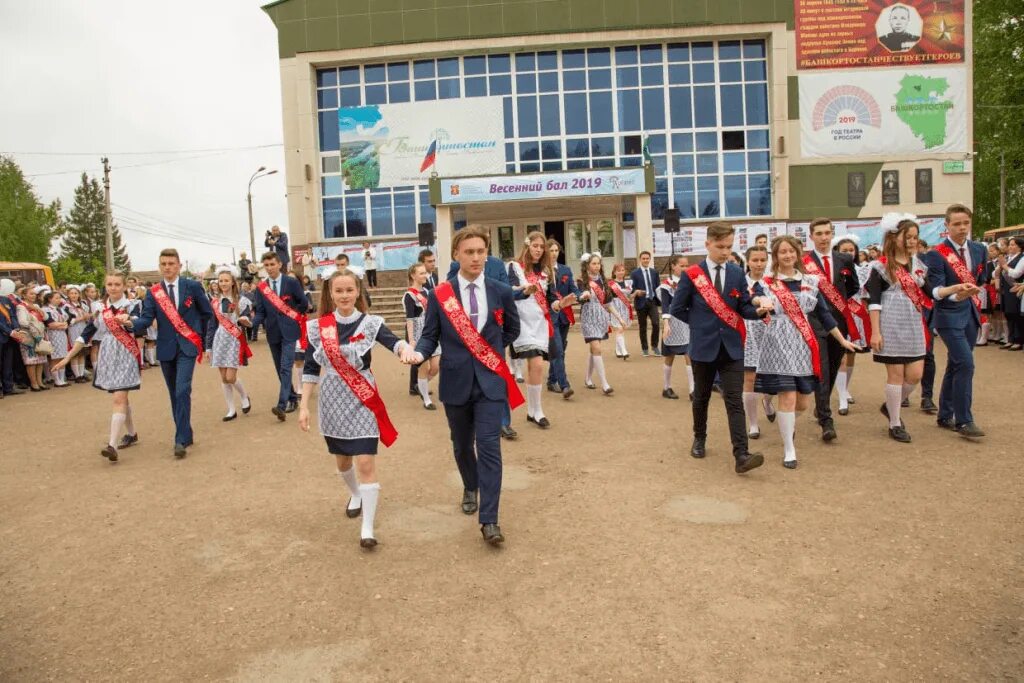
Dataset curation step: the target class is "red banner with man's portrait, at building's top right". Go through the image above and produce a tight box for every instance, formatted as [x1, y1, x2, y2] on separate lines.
[794, 0, 965, 69]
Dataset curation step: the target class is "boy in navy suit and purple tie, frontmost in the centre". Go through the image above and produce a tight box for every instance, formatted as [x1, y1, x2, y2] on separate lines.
[402, 226, 522, 546]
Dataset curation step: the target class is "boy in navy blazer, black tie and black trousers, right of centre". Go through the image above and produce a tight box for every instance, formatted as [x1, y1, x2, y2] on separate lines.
[672, 221, 771, 474]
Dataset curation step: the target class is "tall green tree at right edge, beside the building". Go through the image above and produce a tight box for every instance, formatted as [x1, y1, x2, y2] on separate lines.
[974, 0, 1024, 230]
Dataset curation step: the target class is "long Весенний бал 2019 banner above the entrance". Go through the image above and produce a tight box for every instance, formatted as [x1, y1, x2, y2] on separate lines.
[441, 168, 647, 204]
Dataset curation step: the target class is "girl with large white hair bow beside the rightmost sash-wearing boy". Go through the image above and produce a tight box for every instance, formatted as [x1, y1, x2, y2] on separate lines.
[867, 214, 932, 443]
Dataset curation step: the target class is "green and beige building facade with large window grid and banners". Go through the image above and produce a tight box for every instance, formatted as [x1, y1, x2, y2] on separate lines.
[264, 0, 973, 269]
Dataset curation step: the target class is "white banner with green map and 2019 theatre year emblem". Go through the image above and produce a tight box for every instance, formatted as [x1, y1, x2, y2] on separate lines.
[800, 67, 968, 157]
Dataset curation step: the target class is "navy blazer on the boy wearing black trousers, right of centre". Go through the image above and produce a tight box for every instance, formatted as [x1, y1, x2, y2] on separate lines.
[671, 259, 761, 362]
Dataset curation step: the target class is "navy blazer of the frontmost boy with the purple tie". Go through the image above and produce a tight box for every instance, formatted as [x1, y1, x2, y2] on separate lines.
[416, 268, 519, 405]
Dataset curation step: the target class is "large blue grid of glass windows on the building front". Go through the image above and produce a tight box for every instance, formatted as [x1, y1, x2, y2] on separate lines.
[315, 40, 773, 239]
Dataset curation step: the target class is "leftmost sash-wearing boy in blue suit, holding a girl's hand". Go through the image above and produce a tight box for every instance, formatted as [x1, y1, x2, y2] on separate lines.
[131, 249, 213, 459]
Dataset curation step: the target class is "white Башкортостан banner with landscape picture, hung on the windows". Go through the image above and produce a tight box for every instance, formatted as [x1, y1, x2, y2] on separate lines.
[338, 97, 505, 189]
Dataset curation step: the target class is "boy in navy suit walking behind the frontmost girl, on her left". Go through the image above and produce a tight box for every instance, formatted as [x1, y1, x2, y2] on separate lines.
[253, 252, 309, 422]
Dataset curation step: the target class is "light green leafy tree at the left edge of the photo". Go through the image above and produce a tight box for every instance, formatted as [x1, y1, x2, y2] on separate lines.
[0, 157, 61, 263]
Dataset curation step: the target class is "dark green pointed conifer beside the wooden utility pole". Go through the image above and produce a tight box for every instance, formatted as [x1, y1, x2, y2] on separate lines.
[60, 173, 131, 282]
